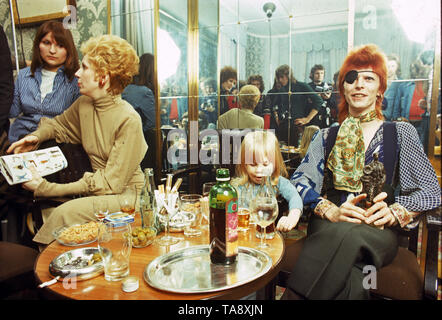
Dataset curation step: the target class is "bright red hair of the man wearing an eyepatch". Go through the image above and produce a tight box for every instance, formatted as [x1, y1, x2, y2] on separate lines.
[338, 44, 387, 123]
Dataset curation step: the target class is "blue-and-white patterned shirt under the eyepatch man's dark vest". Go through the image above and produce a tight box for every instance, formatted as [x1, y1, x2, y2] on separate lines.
[291, 122, 441, 228]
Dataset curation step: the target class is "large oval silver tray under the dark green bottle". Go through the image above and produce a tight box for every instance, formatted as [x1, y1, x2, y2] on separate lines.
[143, 245, 272, 293]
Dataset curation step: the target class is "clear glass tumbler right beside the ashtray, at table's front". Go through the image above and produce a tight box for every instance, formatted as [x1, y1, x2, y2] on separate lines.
[98, 222, 132, 281]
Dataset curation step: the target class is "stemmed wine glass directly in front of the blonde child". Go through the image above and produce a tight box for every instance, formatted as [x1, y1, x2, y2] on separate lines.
[251, 196, 278, 249]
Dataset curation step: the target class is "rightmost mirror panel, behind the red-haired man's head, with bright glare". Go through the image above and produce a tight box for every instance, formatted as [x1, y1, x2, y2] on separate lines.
[354, 0, 440, 154]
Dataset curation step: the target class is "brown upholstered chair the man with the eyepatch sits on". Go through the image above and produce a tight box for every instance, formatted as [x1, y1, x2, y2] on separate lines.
[268, 207, 441, 300]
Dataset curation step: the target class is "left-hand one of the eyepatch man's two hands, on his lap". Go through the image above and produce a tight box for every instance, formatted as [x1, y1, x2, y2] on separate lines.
[324, 193, 367, 223]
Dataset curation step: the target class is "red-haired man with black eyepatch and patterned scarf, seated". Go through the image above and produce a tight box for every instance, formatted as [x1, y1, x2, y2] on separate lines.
[282, 45, 441, 300]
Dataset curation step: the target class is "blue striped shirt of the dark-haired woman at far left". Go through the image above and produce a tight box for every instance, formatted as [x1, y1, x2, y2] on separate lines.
[8, 67, 80, 143]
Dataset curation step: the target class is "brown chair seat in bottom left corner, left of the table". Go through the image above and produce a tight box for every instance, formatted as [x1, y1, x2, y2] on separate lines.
[0, 241, 38, 299]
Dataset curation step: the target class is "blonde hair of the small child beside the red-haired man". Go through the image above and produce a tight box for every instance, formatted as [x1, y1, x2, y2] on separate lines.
[236, 130, 288, 185]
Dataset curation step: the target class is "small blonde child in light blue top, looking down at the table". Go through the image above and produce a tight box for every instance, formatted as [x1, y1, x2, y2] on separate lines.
[232, 131, 303, 232]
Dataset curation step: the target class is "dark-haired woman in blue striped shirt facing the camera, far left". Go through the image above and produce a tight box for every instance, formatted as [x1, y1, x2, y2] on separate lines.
[8, 21, 80, 143]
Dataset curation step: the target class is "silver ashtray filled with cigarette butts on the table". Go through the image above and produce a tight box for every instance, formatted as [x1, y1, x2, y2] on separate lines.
[49, 247, 104, 281]
